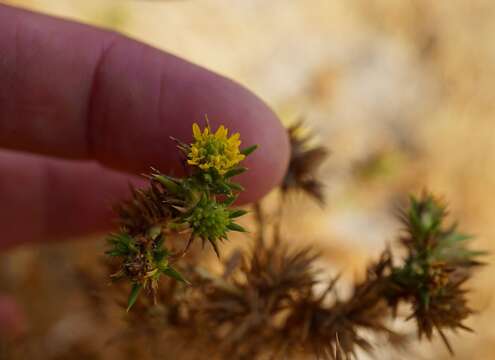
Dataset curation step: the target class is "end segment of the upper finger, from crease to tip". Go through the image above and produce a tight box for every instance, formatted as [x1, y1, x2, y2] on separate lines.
[88, 39, 289, 201]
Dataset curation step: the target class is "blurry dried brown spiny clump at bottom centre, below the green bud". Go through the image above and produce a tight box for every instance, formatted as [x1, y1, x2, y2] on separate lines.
[188, 242, 316, 359]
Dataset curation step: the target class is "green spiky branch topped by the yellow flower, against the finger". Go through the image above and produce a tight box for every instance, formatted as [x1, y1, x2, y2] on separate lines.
[107, 122, 256, 310]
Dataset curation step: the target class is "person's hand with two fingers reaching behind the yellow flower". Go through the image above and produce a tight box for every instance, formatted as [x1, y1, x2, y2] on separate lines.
[0, 5, 289, 338]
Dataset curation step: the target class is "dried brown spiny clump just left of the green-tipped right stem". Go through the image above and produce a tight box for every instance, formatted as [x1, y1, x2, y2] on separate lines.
[283, 252, 400, 359]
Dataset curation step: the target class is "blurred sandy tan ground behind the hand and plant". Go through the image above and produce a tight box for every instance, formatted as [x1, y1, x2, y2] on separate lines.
[0, 0, 495, 360]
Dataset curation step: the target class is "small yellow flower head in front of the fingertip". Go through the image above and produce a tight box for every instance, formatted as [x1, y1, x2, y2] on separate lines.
[187, 123, 245, 175]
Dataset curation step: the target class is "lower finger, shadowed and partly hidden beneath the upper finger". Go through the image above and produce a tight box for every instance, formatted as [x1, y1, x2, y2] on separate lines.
[0, 151, 145, 250]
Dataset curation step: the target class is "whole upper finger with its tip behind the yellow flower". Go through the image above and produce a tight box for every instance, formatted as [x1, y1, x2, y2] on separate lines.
[0, 5, 289, 201]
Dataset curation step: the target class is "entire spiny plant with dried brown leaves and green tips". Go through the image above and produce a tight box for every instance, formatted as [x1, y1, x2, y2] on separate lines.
[90, 120, 482, 360]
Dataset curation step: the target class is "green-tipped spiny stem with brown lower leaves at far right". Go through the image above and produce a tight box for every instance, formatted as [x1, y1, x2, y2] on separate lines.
[388, 194, 484, 350]
